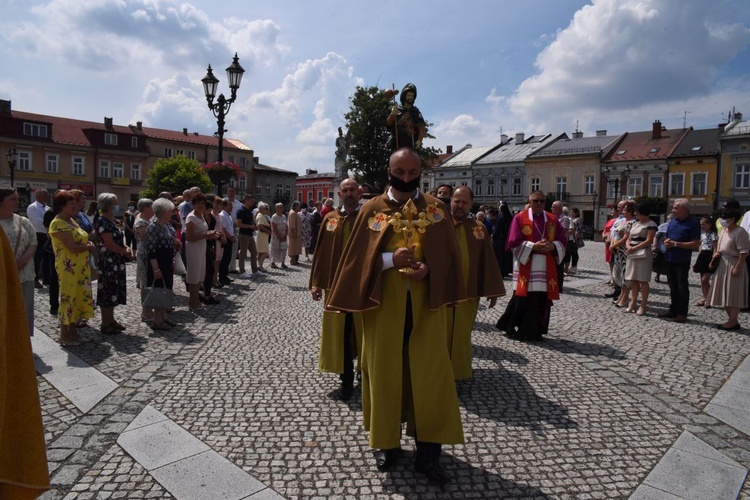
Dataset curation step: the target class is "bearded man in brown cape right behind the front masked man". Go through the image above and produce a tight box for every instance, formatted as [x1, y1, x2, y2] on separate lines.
[449, 186, 505, 380]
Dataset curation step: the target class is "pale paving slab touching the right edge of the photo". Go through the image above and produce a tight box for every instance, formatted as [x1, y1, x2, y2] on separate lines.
[703, 356, 750, 434]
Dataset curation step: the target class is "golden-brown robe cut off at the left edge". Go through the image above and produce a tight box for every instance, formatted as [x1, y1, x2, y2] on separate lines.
[0, 231, 49, 500]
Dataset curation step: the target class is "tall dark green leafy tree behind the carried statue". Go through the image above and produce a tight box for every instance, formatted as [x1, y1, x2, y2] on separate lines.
[344, 86, 441, 193]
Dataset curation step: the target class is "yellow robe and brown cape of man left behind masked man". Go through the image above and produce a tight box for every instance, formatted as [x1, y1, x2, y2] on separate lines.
[310, 210, 362, 373]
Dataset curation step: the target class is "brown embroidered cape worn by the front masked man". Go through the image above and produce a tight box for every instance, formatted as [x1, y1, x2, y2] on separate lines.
[328, 193, 466, 312]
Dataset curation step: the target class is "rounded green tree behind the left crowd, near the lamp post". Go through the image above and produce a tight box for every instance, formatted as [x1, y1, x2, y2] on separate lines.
[141, 155, 213, 200]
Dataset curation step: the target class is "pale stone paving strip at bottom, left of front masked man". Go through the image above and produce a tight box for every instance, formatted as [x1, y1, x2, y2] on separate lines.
[117, 405, 283, 500]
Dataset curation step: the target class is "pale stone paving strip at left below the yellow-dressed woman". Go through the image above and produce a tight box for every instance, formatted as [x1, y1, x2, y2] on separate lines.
[31, 328, 118, 413]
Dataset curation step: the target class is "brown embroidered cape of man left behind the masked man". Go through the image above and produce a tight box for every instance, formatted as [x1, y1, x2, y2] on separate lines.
[310, 210, 357, 290]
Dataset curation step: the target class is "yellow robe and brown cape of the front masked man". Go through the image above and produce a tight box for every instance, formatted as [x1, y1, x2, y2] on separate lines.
[328, 191, 466, 449]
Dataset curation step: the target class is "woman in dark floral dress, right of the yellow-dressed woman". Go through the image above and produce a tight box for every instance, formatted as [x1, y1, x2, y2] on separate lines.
[94, 193, 133, 333]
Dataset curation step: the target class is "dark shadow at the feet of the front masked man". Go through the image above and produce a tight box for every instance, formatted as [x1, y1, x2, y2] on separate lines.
[383, 452, 549, 499]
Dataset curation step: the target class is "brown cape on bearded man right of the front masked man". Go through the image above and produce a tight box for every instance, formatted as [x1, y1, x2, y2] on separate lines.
[456, 219, 505, 299]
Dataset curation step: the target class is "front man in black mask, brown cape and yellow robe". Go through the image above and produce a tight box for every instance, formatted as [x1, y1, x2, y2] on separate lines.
[328, 148, 466, 484]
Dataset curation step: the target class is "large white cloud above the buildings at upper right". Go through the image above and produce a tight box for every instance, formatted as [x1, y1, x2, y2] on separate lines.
[509, 0, 750, 130]
